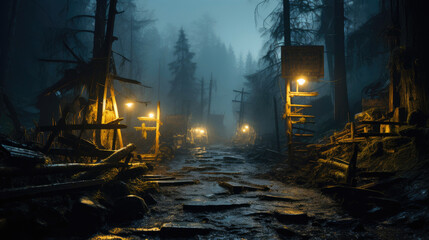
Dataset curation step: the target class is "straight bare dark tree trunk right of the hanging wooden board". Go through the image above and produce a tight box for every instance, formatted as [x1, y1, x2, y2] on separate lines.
[334, 0, 349, 124]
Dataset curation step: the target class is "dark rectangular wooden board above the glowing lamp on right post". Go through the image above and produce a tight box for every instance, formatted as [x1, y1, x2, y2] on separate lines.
[282, 46, 324, 80]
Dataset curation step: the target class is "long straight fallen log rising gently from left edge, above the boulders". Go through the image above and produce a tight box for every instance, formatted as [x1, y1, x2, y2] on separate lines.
[0, 179, 105, 202]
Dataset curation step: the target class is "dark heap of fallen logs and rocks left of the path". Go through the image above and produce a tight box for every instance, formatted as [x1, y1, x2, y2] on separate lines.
[0, 135, 158, 239]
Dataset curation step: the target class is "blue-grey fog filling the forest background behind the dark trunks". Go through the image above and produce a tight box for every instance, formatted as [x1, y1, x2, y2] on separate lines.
[1, 0, 388, 144]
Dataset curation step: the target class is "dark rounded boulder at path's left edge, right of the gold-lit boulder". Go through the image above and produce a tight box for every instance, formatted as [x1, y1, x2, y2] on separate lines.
[112, 195, 149, 221]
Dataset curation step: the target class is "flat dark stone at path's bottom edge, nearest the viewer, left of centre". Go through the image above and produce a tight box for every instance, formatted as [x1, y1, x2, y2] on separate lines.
[161, 222, 214, 237]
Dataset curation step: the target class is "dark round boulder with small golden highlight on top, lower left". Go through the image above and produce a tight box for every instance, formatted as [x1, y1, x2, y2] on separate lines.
[70, 197, 107, 235]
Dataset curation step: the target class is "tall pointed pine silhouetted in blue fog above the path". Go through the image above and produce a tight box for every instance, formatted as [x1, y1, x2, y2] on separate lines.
[169, 28, 197, 115]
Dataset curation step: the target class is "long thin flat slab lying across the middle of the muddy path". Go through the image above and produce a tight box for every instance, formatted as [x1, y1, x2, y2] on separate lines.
[183, 201, 250, 212]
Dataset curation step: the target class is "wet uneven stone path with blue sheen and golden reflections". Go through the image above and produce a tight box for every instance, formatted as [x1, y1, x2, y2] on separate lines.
[104, 146, 378, 239]
